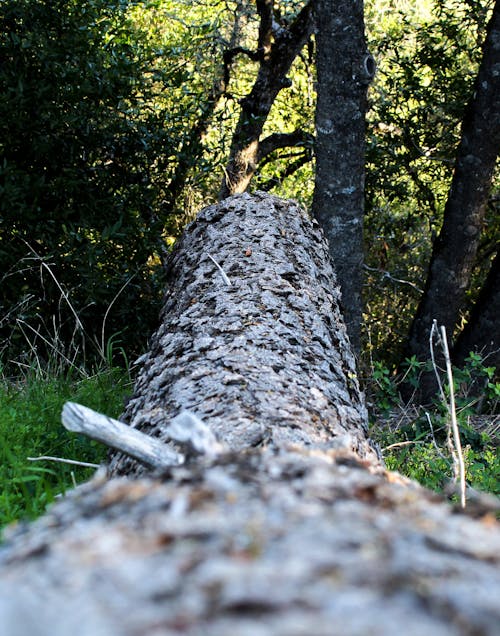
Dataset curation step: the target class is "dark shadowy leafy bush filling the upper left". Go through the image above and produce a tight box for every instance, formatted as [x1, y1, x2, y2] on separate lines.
[0, 0, 176, 362]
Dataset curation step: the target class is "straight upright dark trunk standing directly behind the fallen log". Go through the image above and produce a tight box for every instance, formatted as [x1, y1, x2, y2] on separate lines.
[313, 0, 375, 352]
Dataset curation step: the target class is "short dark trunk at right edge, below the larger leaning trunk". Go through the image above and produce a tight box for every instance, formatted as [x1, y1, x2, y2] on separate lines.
[453, 247, 500, 372]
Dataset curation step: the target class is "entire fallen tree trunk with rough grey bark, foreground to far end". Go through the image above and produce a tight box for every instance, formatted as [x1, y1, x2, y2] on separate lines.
[0, 195, 500, 636]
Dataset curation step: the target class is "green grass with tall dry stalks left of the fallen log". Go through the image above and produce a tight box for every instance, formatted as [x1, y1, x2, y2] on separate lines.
[0, 257, 138, 533]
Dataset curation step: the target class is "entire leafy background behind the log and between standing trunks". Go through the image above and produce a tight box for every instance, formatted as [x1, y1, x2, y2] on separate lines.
[0, 0, 500, 376]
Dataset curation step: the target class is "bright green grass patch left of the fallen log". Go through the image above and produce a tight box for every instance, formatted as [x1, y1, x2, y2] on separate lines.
[0, 369, 131, 529]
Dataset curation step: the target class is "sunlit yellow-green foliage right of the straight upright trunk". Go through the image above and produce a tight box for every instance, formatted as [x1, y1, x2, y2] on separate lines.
[365, 0, 500, 363]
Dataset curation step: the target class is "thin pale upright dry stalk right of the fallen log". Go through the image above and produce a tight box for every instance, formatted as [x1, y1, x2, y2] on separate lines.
[429, 320, 466, 508]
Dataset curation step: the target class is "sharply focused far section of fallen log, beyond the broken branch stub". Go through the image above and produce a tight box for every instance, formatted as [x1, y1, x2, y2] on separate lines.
[111, 193, 374, 474]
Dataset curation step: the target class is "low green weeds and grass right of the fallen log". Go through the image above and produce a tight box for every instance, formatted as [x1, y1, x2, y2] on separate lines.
[368, 354, 500, 496]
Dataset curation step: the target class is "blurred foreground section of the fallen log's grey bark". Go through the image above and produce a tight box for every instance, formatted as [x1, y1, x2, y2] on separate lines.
[0, 449, 500, 636]
